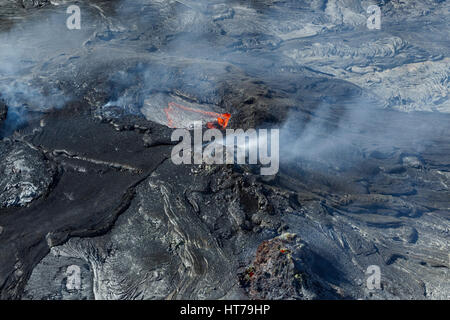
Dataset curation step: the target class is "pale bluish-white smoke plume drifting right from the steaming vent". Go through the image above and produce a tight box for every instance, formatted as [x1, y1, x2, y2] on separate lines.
[280, 92, 444, 170]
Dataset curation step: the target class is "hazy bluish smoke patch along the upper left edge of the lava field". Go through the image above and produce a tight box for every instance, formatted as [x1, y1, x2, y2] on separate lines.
[0, 1, 98, 135]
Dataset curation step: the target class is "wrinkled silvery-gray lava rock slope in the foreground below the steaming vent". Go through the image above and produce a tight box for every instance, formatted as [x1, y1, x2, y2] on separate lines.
[22, 161, 279, 299]
